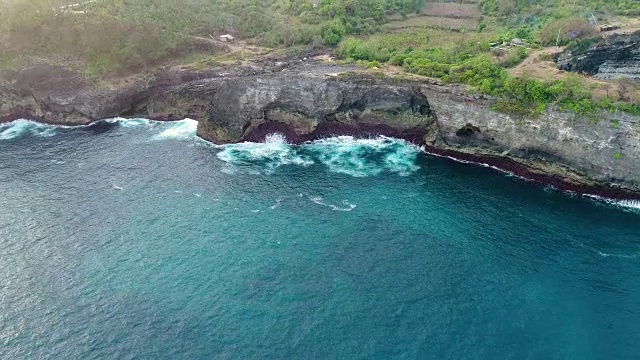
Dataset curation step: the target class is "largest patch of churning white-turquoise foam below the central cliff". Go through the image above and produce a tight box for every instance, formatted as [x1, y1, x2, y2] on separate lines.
[217, 134, 421, 177]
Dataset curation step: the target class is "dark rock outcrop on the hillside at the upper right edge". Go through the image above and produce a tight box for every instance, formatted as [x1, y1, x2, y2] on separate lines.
[558, 32, 640, 79]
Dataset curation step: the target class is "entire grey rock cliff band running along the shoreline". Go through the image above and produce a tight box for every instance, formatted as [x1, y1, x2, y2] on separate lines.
[0, 61, 640, 198]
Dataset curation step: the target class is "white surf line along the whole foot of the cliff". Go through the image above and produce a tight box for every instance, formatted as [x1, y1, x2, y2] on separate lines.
[0, 117, 640, 212]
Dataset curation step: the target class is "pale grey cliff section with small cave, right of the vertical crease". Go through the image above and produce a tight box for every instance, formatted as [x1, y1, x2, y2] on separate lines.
[422, 86, 640, 191]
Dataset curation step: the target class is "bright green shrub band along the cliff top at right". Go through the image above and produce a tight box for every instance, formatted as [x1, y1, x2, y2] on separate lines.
[335, 25, 637, 120]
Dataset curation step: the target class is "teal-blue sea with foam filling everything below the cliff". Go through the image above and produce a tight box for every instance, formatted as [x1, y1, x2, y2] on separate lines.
[0, 120, 640, 359]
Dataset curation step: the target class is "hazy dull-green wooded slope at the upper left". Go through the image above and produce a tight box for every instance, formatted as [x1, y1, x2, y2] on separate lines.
[0, 0, 424, 75]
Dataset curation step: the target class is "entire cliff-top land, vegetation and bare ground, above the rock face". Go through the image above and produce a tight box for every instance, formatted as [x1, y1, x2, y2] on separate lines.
[0, 0, 640, 116]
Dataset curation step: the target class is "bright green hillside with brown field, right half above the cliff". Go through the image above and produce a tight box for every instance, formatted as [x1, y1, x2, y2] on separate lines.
[335, 0, 640, 115]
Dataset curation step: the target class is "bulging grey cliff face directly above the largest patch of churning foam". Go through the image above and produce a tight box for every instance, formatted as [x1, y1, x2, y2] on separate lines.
[148, 73, 434, 143]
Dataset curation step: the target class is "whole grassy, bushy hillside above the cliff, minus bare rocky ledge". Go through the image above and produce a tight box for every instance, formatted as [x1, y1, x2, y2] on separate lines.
[0, 0, 640, 115]
